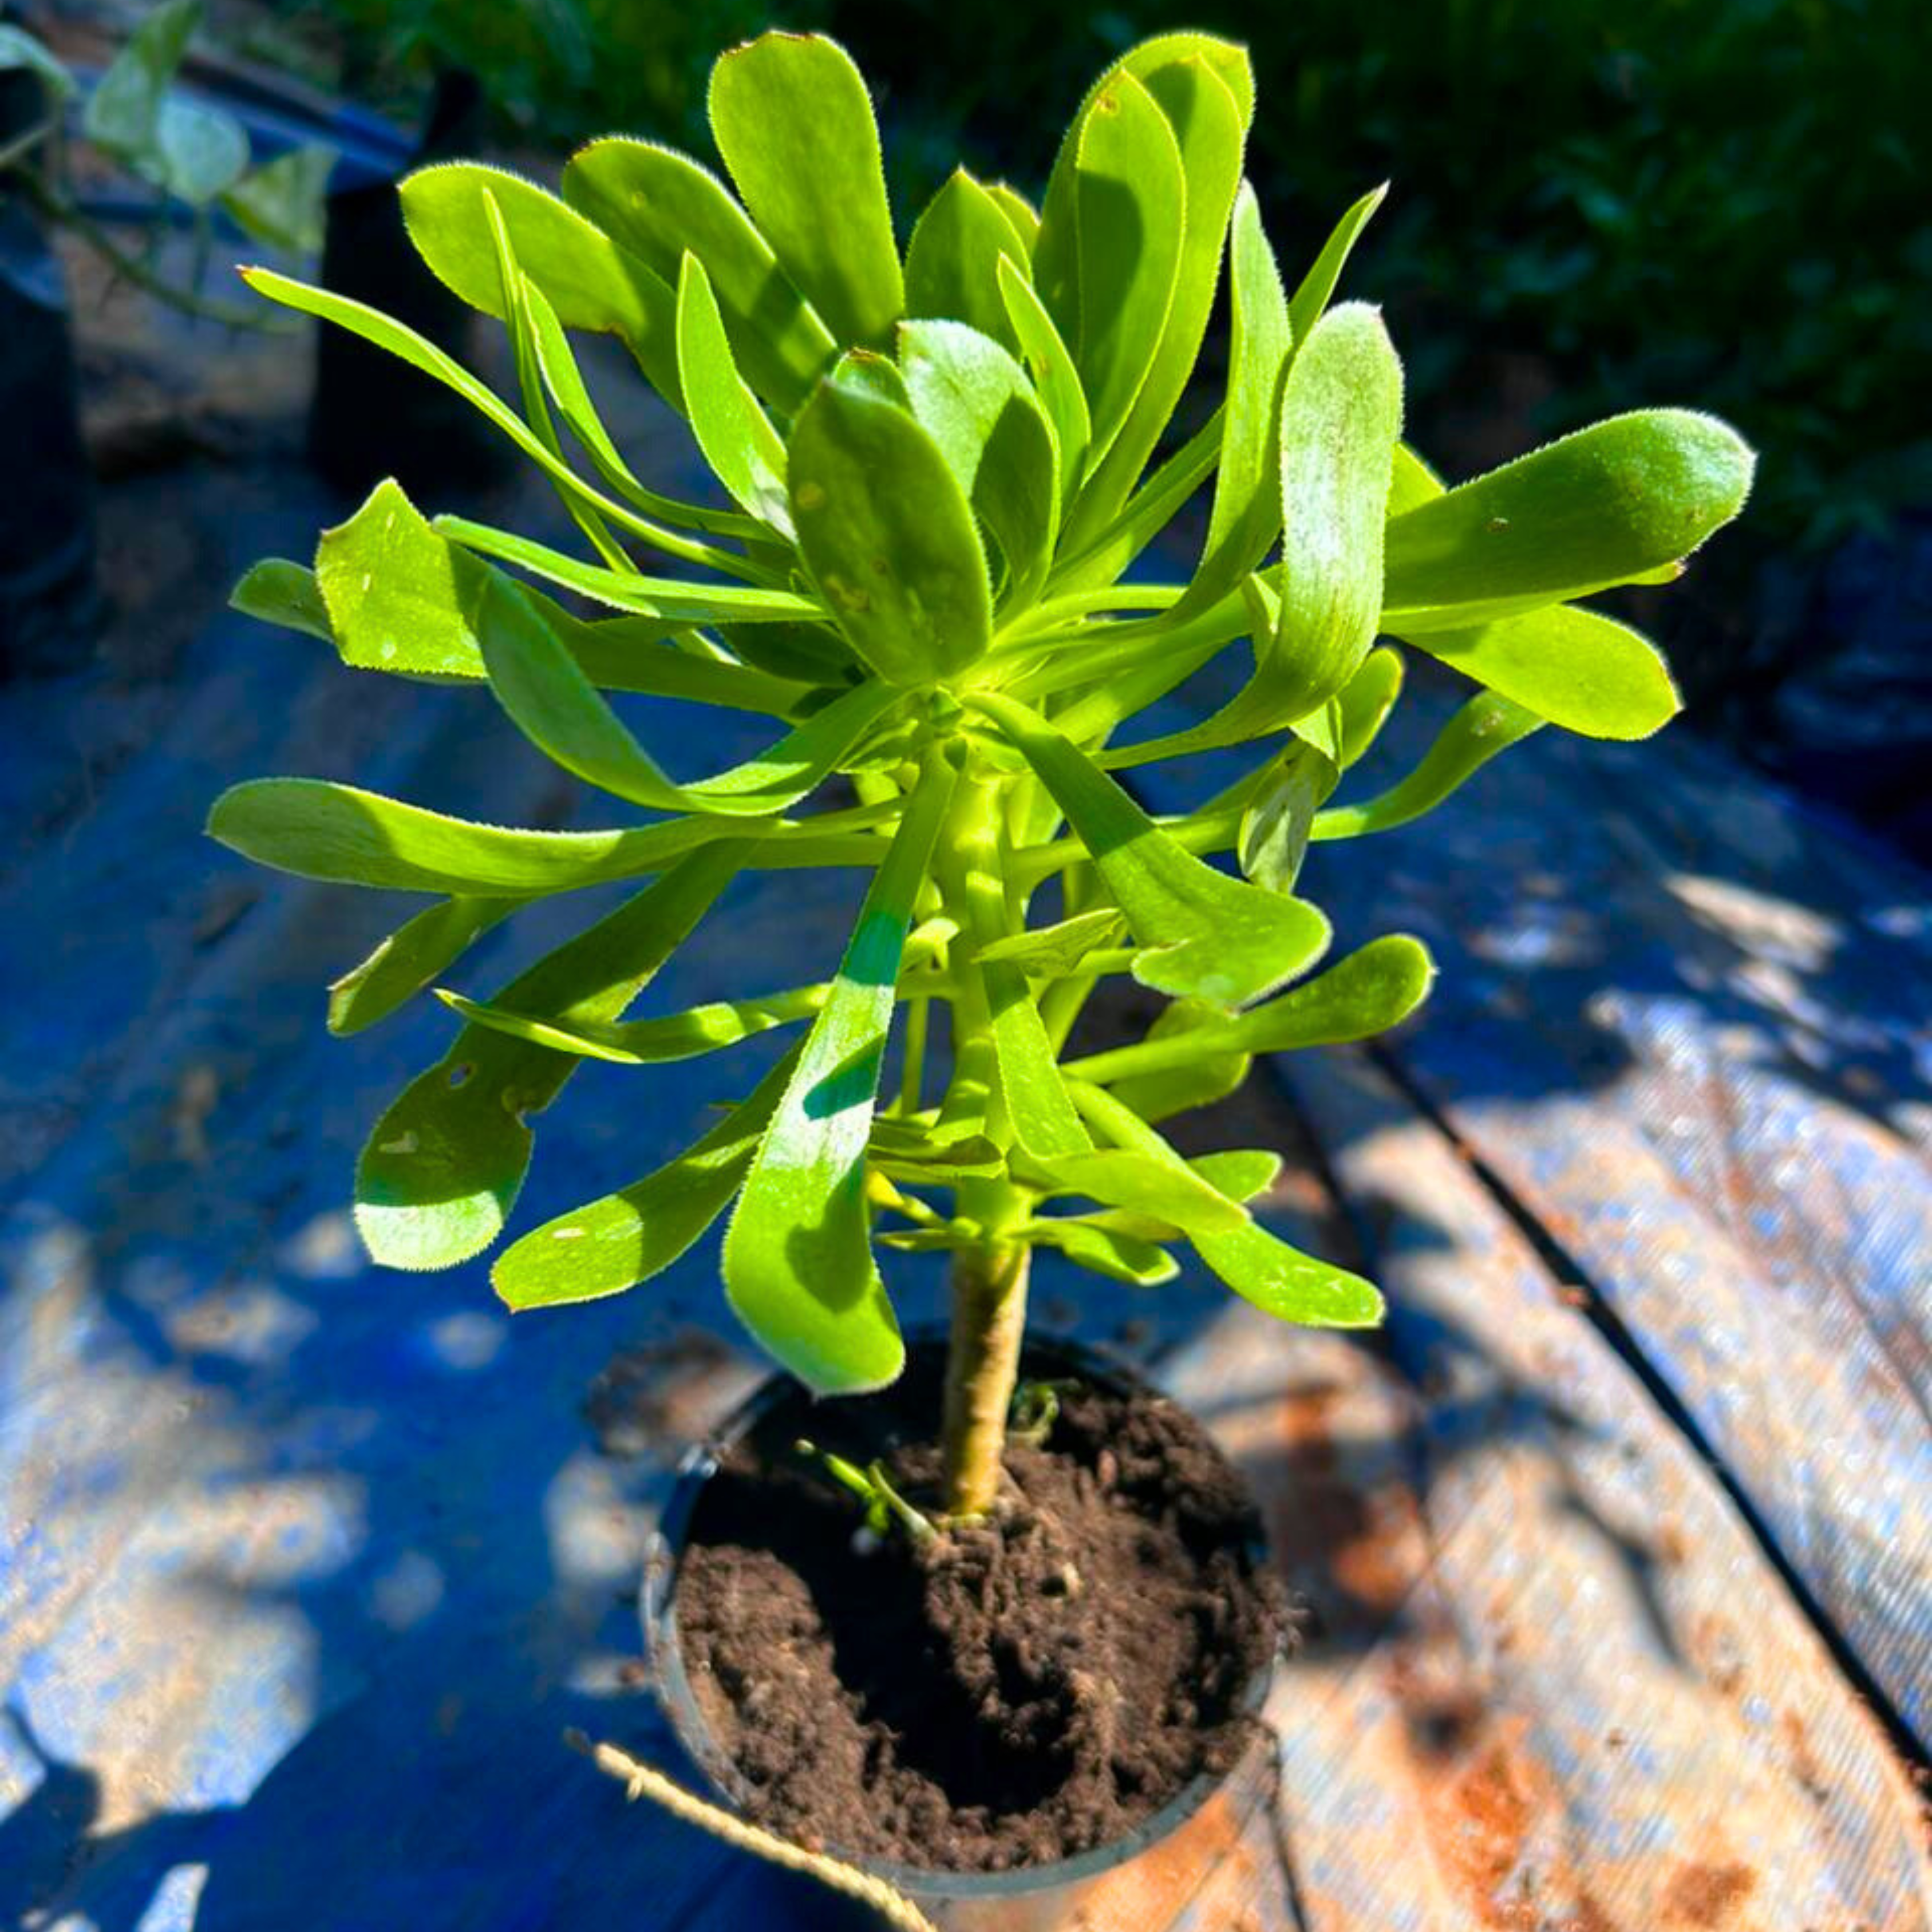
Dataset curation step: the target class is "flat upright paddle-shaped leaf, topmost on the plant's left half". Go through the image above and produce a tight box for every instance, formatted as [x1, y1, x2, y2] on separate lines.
[711, 33, 904, 348]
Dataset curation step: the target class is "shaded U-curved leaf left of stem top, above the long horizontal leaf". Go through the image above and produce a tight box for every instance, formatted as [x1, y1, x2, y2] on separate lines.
[477, 578, 900, 817]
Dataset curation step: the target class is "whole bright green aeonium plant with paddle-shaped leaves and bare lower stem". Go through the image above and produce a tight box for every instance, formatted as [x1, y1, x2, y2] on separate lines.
[211, 33, 1752, 1519]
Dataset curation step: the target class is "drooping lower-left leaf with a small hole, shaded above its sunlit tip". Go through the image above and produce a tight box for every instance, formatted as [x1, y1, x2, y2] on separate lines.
[355, 843, 750, 1269]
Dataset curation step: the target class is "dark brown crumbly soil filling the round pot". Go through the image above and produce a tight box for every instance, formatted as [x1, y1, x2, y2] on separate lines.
[676, 1350, 1283, 1870]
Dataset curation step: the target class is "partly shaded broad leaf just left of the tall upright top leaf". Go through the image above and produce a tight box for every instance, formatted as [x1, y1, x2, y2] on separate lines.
[564, 137, 836, 416]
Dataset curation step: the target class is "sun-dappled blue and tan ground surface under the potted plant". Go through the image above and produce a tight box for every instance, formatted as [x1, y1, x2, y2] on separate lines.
[0, 373, 1932, 1932]
